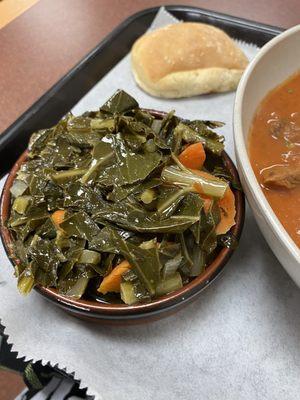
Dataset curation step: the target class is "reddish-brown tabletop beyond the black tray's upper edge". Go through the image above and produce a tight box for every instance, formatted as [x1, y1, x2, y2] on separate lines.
[0, 0, 300, 132]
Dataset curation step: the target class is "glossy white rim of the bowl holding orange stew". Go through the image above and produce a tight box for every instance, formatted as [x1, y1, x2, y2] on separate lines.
[233, 25, 300, 264]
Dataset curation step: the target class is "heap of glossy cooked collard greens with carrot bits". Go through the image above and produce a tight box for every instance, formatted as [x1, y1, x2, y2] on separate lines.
[8, 91, 235, 305]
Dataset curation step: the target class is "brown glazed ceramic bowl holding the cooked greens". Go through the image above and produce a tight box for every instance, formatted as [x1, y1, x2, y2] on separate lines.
[0, 110, 245, 325]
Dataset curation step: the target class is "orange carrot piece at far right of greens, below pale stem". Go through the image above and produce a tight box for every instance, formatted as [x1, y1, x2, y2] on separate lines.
[216, 187, 236, 235]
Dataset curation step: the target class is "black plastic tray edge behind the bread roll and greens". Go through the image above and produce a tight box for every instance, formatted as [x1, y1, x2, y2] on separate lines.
[0, 6, 282, 177]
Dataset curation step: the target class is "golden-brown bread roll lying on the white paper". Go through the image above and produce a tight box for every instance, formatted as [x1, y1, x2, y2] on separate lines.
[131, 22, 248, 98]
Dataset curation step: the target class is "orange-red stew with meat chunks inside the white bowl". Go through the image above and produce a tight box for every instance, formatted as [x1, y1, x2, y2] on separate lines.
[249, 72, 300, 247]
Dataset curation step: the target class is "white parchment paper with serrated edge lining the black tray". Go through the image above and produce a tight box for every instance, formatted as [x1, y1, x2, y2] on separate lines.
[0, 7, 300, 400]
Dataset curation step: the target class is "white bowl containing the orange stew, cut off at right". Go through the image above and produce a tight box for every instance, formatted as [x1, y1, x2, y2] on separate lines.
[233, 25, 300, 287]
